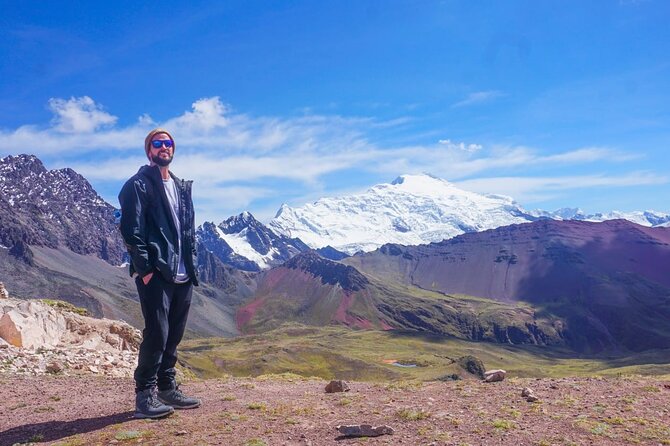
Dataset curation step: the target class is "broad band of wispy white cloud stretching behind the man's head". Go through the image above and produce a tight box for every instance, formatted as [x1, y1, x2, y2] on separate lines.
[0, 97, 666, 225]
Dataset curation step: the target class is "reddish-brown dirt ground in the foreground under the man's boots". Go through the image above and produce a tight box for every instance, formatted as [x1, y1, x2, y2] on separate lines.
[0, 375, 670, 446]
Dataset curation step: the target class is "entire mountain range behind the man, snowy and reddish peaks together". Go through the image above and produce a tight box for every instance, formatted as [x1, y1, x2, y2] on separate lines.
[0, 155, 670, 354]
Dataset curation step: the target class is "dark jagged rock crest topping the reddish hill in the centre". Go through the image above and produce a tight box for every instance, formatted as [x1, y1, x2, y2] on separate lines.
[283, 251, 369, 291]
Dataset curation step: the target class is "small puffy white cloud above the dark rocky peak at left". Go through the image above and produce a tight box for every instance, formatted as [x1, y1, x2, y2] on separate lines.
[49, 96, 118, 133]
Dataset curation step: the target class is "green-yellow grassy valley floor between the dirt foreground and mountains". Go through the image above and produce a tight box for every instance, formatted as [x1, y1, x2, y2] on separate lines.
[180, 324, 670, 381]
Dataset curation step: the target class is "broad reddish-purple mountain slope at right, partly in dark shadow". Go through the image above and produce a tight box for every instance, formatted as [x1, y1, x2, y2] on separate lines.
[344, 220, 670, 350]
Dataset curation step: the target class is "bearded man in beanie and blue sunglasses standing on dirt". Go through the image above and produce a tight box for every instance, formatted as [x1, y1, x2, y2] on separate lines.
[119, 129, 200, 418]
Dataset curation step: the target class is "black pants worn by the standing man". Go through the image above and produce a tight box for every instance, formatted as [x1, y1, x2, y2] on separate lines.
[135, 271, 193, 392]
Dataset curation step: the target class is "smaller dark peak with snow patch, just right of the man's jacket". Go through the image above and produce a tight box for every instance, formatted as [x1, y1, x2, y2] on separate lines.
[196, 212, 309, 271]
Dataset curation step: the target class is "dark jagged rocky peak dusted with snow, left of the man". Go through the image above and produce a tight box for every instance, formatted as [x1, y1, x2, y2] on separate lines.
[0, 154, 126, 264]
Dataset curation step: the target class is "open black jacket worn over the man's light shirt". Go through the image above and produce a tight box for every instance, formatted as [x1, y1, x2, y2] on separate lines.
[119, 166, 198, 285]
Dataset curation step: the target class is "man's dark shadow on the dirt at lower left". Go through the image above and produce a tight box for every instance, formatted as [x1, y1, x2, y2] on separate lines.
[0, 411, 133, 446]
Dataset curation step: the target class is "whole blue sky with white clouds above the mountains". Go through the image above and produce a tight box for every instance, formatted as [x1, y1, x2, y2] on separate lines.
[0, 0, 670, 222]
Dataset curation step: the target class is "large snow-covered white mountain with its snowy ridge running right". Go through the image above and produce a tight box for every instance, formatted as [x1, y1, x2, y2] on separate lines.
[268, 174, 670, 254]
